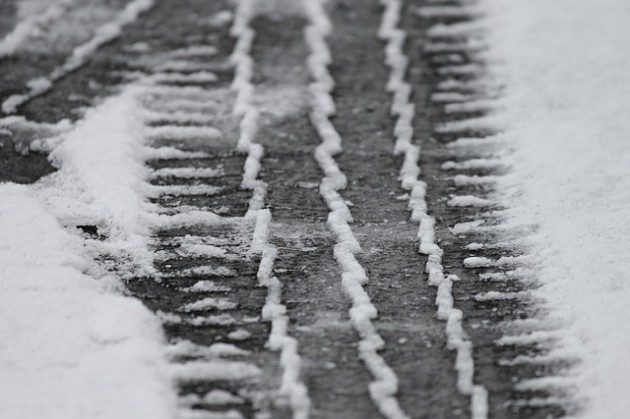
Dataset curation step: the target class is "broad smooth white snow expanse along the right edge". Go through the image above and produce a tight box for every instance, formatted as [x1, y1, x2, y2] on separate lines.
[482, 0, 630, 418]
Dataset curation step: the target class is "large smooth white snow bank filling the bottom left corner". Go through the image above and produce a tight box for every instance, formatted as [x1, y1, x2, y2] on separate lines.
[0, 184, 175, 419]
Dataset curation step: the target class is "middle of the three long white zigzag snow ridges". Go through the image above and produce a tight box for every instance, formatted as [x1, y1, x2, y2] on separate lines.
[303, 0, 408, 419]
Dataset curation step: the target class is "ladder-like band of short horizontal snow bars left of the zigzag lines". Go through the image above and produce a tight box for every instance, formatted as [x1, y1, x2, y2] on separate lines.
[101, 16, 265, 419]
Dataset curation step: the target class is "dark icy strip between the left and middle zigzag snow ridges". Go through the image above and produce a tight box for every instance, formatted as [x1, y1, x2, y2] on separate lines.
[252, 8, 388, 418]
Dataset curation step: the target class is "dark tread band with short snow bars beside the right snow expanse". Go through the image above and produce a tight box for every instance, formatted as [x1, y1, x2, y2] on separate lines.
[405, 1, 573, 418]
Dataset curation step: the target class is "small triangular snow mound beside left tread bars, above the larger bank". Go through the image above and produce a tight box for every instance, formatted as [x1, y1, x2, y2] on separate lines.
[35, 89, 152, 275]
